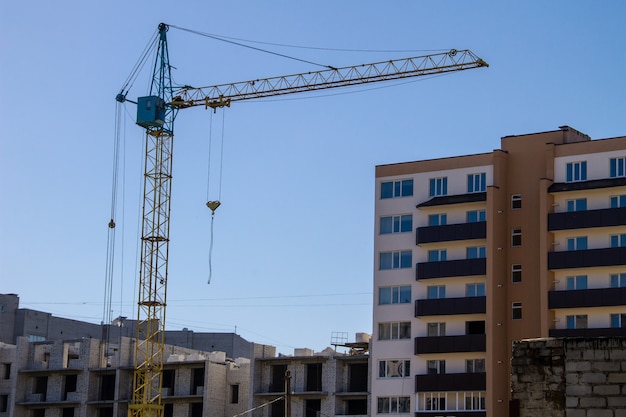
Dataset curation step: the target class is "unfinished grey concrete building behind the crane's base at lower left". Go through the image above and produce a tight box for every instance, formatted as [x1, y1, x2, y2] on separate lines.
[0, 337, 251, 417]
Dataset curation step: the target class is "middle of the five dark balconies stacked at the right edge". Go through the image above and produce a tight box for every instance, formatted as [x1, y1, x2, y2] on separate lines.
[544, 247, 626, 269]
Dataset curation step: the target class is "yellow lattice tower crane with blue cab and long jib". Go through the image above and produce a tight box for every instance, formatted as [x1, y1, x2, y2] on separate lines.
[116, 23, 489, 417]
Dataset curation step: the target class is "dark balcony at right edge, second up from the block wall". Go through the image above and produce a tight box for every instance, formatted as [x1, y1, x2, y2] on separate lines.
[548, 288, 626, 309]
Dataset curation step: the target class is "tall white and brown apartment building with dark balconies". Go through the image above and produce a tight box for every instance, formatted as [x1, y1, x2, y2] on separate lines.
[370, 126, 626, 417]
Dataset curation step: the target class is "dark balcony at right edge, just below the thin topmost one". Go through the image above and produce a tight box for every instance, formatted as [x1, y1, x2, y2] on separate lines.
[548, 207, 626, 231]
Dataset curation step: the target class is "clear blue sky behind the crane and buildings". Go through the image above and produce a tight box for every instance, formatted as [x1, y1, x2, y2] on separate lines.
[0, 0, 626, 353]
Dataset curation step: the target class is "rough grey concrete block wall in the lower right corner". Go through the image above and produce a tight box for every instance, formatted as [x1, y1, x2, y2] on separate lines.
[511, 338, 626, 417]
